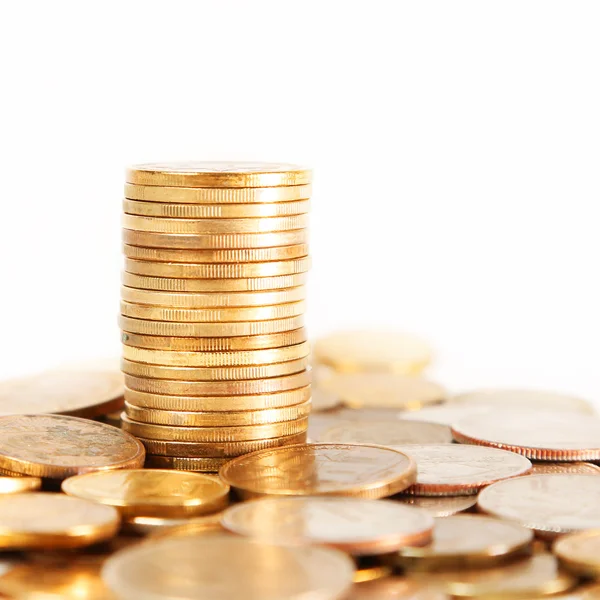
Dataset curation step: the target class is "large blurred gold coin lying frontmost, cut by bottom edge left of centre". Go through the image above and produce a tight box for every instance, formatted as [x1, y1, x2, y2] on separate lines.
[102, 534, 354, 600]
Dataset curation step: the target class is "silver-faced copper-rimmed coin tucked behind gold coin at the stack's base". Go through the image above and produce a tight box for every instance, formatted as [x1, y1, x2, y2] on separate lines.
[397, 444, 531, 496]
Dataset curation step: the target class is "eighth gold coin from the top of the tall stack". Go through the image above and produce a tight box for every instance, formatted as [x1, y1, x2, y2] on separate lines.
[122, 273, 306, 292]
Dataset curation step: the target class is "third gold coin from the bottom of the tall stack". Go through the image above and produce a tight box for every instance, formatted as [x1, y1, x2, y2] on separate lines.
[121, 414, 308, 442]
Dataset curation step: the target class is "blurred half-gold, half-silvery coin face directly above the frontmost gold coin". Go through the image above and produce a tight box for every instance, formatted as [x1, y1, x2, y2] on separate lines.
[222, 497, 434, 556]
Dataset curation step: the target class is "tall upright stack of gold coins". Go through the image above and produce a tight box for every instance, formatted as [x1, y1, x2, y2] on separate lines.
[120, 163, 311, 472]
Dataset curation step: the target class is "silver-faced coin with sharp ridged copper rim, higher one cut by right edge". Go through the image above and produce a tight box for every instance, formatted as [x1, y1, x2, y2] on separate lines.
[452, 412, 600, 461]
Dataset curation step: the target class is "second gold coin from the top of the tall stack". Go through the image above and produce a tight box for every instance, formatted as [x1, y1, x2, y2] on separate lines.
[125, 183, 312, 204]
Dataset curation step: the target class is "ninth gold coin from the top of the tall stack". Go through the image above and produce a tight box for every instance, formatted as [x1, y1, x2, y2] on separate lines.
[121, 285, 306, 309]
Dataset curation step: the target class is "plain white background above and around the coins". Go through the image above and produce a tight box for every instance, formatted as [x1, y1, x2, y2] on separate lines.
[0, 0, 600, 401]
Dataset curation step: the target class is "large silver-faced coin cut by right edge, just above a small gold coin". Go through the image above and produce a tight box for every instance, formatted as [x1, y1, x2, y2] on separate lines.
[477, 475, 600, 539]
